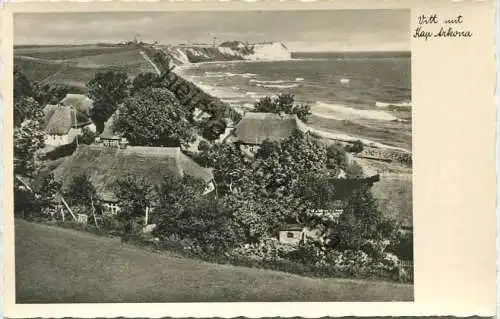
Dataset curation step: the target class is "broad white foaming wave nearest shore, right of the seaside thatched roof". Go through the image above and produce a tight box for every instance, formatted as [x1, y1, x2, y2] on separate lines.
[311, 102, 399, 121]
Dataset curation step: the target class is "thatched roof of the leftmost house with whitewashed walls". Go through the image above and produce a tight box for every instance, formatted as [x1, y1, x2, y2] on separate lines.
[43, 104, 92, 135]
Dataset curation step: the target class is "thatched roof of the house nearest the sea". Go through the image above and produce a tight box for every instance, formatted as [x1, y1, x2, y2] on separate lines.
[232, 112, 305, 145]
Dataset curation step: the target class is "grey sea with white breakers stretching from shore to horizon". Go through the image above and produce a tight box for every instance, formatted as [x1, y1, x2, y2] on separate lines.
[180, 52, 412, 151]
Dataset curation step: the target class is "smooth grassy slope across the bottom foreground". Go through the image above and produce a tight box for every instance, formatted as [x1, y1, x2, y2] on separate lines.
[15, 220, 413, 303]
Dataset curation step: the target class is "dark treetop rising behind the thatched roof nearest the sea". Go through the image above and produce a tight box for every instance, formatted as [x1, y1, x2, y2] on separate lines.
[254, 93, 311, 122]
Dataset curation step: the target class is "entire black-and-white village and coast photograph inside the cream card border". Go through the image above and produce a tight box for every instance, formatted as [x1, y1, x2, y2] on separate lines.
[13, 9, 414, 304]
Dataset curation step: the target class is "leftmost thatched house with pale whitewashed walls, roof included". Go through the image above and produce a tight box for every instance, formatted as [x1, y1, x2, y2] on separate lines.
[43, 104, 95, 147]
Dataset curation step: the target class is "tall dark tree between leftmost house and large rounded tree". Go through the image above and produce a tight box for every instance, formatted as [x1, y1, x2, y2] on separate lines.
[87, 71, 129, 132]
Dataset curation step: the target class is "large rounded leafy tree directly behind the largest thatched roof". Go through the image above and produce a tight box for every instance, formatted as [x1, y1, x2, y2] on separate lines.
[114, 88, 195, 146]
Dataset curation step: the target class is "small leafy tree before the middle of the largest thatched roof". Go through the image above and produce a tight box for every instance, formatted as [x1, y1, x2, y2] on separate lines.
[114, 176, 154, 238]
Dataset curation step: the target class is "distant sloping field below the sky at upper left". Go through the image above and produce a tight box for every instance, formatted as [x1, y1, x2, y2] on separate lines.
[14, 46, 154, 92]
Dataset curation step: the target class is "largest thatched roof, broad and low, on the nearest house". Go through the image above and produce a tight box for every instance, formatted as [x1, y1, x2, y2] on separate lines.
[54, 145, 212, 200]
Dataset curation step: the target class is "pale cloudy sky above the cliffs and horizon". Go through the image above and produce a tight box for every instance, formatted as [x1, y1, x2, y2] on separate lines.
[14, 10, 410, 51]
